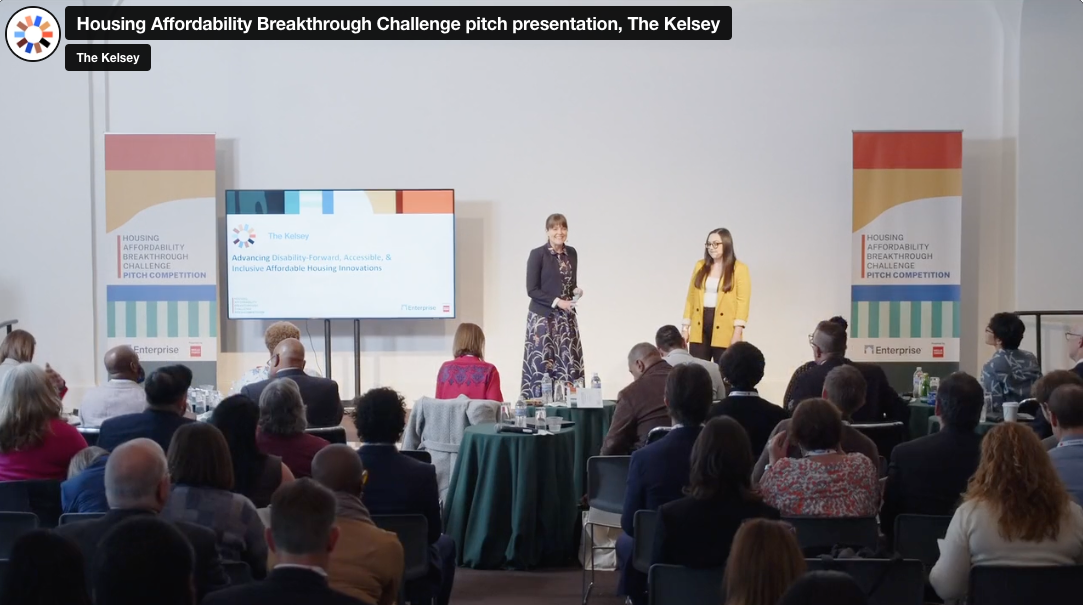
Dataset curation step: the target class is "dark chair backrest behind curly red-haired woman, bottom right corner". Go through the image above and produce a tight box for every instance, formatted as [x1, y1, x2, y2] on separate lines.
[968, 565, 1083, 605]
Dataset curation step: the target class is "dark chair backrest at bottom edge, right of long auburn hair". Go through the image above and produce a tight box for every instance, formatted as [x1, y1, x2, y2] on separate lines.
[805, 557, 925, 605]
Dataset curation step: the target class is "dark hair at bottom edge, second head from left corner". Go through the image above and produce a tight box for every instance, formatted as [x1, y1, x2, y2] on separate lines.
[91, 515, 195, 605]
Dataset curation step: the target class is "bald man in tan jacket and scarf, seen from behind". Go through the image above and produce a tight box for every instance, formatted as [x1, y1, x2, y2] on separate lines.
[311, 444, 405, 605]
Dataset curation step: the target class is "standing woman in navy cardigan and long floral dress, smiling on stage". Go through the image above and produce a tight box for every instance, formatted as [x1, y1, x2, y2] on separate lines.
[520, 214, 583, 399]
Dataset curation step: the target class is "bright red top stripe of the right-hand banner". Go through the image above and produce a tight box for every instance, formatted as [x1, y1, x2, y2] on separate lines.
[853, 132, 963, 170]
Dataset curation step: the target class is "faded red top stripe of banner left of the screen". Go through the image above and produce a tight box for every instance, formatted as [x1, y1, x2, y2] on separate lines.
[105, 134, 214, 170]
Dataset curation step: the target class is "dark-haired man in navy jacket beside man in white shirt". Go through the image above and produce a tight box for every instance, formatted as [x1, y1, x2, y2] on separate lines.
[97, 365, 195, 451]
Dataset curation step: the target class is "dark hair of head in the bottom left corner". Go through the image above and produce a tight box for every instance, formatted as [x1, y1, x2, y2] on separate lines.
[0, 529, 90, 605]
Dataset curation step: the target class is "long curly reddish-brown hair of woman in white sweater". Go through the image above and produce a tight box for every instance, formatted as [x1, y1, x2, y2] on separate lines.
[963, 422, 1070, 542]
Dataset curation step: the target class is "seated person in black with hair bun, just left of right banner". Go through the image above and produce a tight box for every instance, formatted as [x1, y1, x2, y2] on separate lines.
[785, 317, 910, 425]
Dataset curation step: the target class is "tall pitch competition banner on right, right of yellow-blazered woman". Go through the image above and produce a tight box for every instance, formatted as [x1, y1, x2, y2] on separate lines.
[848, 131, 963, 363]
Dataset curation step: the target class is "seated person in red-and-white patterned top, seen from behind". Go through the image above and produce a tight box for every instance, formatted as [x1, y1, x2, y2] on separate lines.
[759, 399, 879, 517]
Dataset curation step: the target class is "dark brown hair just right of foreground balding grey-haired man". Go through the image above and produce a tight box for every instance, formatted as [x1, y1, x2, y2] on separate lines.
[167, 422, 233, 491]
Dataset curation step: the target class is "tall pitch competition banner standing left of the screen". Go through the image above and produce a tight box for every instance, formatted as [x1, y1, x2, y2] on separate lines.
[97, 134, 218, 384]
